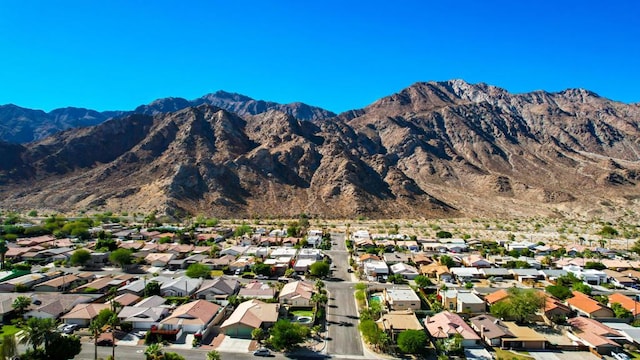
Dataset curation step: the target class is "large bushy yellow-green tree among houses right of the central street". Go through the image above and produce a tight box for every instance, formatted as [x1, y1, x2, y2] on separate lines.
[491, 287, 545, 323]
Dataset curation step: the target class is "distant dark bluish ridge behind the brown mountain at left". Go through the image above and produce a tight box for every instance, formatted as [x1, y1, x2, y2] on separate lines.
[0, 91, 336, 144]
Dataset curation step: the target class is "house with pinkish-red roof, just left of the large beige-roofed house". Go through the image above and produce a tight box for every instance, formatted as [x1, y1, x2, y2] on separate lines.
[156, 300, 224, 337]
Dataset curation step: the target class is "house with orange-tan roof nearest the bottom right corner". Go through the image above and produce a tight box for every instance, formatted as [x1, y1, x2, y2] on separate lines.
[567, 316, 626, 354]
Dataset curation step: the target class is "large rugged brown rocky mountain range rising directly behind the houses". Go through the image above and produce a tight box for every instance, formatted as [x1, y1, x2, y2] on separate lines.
[0, 80, 640, 218]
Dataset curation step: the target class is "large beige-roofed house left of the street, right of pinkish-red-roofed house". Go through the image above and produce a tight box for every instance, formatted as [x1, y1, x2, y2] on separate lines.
[220, 299, 280, 339]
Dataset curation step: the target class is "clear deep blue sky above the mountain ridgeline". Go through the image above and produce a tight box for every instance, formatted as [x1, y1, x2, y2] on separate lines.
[0, 0, 640, 112]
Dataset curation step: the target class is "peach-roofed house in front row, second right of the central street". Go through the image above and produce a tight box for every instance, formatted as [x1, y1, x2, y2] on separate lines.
[424, 311, 482, 348]
